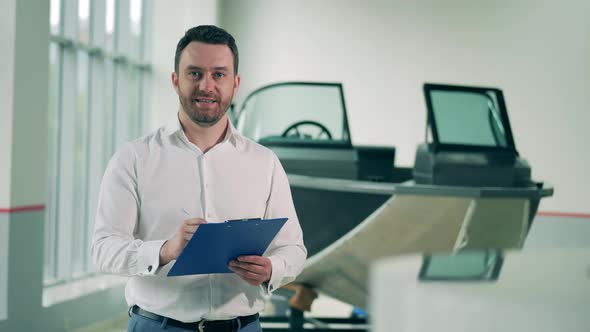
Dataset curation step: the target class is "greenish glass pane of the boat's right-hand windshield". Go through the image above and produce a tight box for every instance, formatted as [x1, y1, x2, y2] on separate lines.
[429, 90, 509, 148]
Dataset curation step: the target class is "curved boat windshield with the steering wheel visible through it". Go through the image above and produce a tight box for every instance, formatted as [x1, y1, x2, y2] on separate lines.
[237, 82, 351, 146]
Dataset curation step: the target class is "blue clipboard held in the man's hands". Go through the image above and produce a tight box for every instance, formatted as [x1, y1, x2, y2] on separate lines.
[168, 218, 287, 277]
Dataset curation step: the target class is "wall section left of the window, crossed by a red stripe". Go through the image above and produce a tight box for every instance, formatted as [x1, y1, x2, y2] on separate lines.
[0, 0, 49, 331]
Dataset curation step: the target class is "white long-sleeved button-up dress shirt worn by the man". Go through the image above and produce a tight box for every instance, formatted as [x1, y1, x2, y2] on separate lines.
[91, 118, 307, 322]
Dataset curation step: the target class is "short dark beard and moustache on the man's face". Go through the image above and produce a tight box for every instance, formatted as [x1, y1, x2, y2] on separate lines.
[178, 88, 233, 127]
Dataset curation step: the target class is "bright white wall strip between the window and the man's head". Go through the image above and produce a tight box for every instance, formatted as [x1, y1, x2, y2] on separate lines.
[147, 0, 217, 131]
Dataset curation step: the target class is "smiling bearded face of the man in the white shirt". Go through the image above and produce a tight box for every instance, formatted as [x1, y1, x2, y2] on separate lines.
[172, 42, 240, 127]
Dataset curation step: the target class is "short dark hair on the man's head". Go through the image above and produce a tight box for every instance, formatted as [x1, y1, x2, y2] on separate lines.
[174, 25, 239, 74]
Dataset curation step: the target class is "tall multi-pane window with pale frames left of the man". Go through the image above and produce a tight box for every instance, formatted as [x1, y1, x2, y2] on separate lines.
[44, 0, 150, 285]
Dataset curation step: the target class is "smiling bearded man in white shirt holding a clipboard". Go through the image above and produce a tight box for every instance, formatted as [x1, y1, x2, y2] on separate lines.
[92, 26, 307, 332]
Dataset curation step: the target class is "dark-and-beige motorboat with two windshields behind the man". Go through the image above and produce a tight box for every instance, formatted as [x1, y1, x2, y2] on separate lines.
[232, 82, 553, 308]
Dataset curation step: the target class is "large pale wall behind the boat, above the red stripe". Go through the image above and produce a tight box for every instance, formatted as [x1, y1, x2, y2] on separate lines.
[220, 0, 590, 213]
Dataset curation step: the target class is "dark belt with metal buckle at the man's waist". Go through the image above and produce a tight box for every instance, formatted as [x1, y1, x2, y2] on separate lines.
[129, 305, 258, 332]
